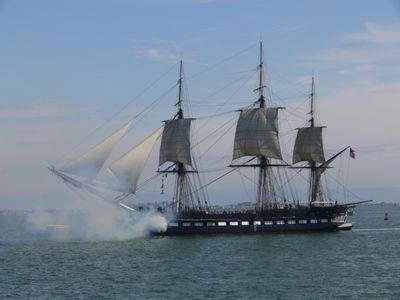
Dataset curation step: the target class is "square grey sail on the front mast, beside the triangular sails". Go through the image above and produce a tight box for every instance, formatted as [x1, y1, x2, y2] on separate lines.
[159, 119, 192, 166]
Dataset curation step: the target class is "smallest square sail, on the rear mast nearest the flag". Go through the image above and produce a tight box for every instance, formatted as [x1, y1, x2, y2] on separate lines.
[293, 127, 325, 164]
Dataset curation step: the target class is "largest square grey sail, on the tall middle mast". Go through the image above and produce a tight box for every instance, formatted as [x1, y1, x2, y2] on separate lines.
[233, 107, 282, 159]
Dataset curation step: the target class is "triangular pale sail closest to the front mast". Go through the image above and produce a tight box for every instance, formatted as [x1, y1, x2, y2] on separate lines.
[99, 128, 162, 194]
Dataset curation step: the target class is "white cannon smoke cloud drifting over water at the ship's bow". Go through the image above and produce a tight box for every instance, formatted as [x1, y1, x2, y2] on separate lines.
[28, 199, 168, 241]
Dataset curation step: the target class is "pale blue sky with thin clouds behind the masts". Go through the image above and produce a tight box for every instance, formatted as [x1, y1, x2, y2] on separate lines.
[0, 0, 400, 209]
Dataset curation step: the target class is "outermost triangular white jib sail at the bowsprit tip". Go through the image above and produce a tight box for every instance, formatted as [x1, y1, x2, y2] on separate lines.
[60, 122, 131, 179]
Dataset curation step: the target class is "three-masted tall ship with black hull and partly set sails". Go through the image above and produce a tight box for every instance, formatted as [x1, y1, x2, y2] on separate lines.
[49, 43, 365, 236]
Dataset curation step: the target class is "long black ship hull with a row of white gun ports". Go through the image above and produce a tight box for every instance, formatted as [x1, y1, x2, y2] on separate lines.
[151, 206, 348, 236]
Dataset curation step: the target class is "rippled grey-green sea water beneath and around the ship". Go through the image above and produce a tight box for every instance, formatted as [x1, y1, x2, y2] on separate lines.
[0, 204, 400, 299]
